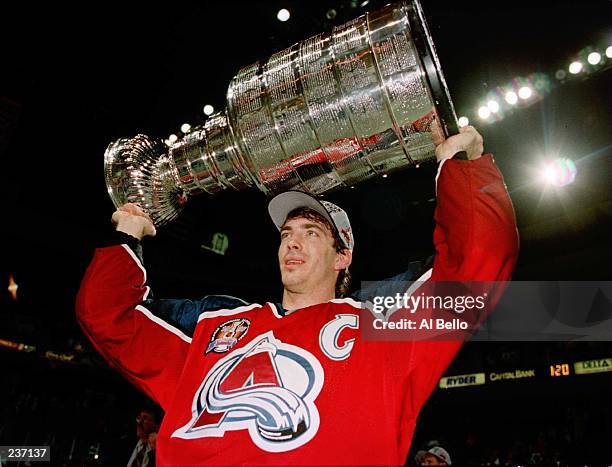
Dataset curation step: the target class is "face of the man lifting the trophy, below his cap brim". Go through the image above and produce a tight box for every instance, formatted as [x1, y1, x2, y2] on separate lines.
[278, 217, 342, 293]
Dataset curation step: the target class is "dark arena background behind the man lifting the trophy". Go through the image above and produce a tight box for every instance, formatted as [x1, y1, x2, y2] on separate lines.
[0, 0, 612, 465]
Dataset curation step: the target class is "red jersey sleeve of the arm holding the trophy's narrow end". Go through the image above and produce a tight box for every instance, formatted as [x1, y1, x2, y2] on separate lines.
[76, 244, 191, 409]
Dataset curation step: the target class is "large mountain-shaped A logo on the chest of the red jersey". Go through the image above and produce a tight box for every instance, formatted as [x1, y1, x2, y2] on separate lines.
[172, 332, 324, 452]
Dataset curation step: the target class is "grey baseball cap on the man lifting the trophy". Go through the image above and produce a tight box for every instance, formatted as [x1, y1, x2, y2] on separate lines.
[268, 190, 355, 251]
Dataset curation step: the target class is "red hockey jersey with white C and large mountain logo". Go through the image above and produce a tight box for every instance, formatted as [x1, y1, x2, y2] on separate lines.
[77, 155, 518, 466]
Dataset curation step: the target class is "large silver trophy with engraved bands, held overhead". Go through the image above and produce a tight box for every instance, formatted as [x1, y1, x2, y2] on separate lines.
[104, 0, 457, 226]
